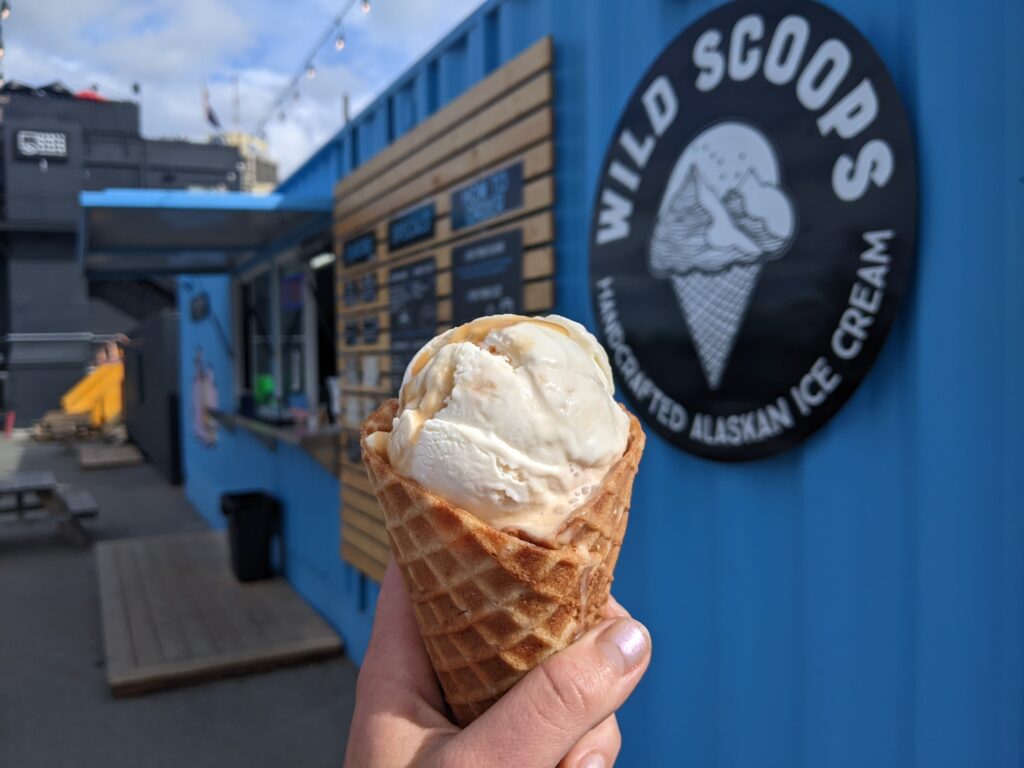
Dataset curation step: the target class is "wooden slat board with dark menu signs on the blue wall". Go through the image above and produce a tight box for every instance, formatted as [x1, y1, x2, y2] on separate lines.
[334, 38, 555, 581]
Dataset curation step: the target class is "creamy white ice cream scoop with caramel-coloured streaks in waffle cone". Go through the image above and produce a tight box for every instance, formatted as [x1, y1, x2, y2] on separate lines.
[371, 314, 629, 541]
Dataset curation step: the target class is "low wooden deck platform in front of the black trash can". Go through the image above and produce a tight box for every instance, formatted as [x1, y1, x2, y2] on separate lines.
[96, 531, 342, 695]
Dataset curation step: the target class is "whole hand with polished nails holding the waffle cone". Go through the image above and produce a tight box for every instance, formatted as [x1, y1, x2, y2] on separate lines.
[345, 561, 650, 768]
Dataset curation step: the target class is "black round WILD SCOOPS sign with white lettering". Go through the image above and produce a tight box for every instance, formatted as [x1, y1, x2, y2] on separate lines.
[591, 0, 918, 461]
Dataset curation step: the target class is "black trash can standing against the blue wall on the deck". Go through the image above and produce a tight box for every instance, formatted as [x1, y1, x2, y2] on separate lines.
[220, 492, 281, 582]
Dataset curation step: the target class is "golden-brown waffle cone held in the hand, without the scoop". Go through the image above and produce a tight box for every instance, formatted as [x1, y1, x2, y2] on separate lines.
[361, 399, 644, 726]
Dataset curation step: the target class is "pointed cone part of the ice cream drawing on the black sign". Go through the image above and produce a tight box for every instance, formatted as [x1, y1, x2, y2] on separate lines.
[672, 263, 762, 389]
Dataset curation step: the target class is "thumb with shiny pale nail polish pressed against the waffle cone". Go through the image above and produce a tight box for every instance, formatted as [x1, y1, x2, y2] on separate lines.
[450, 618, 651, 768]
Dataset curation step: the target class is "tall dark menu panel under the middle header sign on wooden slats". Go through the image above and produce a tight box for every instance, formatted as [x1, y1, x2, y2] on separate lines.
[388, 256, 437, 391]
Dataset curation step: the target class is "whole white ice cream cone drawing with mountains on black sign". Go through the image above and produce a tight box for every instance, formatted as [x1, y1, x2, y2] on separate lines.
[649, 121, 796, 390]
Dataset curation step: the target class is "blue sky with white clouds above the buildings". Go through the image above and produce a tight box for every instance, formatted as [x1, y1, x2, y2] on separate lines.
[3, 0, 482, 178]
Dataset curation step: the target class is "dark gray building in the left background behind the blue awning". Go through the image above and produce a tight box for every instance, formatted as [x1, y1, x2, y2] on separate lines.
[0, 84, 242, 424]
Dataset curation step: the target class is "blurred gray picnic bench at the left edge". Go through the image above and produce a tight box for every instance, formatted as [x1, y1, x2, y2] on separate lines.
[0, 470, 99, 543]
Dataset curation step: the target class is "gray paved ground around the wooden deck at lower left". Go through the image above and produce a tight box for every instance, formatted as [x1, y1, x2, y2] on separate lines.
[0, 438, 356, 768]
